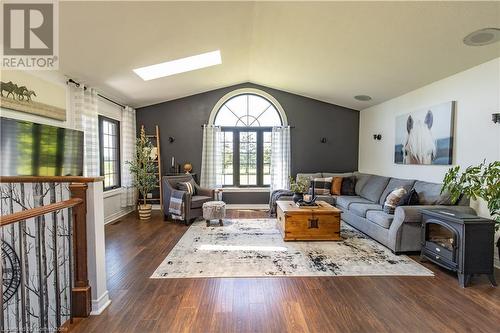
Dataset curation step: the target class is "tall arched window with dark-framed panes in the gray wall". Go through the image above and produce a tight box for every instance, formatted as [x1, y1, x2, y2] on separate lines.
[209, 89, 287, 187]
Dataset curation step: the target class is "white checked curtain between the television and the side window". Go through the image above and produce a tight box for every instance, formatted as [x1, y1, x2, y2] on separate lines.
[70, 84, 99, 177]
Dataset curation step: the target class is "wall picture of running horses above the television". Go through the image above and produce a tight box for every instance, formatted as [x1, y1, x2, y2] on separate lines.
[0, 70, 66, 121]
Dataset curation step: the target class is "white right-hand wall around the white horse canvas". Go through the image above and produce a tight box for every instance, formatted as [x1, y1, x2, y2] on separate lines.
[359, 58, 500, 266]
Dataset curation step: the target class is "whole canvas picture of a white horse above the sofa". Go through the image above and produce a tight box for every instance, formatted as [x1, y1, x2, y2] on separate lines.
[394, 101, 456, 165]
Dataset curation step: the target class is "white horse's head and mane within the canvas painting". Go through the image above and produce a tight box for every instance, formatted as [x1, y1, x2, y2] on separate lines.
[402, 110, 436, 164]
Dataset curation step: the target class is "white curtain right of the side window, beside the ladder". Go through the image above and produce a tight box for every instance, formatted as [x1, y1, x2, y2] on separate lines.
[120, 106, 136, 207]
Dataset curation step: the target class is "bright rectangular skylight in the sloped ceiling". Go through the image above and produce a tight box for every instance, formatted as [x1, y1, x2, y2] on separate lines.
[134, 50, 222, 81]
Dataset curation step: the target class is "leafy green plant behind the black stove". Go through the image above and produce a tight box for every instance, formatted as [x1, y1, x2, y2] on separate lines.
[441, 161, 500, 257]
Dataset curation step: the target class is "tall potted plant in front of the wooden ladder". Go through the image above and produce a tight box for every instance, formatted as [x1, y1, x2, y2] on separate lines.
[126, 127, 157, 220]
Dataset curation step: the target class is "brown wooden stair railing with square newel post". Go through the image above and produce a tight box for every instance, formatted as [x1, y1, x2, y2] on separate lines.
[0, 176, 103, 330]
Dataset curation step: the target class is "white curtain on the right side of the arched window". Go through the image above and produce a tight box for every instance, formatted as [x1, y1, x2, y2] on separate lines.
[271, 126, 291, 191]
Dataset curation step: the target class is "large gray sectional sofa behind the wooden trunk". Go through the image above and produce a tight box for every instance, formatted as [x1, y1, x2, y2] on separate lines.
[272, 172, 476, 253]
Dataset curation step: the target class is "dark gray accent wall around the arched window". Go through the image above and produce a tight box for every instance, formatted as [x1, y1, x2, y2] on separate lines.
[137, 83, 359, 203]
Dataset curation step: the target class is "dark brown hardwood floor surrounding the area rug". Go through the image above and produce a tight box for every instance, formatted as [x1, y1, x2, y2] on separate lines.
[67, 211, 500, 333]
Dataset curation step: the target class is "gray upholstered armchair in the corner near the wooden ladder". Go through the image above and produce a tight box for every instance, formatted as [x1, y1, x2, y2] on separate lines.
[162, 174, 215, 225]
